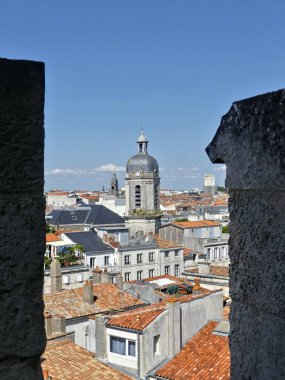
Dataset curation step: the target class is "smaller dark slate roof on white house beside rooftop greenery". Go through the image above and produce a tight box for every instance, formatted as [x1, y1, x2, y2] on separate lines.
[65, 231, 114, 253]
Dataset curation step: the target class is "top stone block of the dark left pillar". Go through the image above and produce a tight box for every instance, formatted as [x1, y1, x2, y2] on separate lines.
[0, 59, 44, 194]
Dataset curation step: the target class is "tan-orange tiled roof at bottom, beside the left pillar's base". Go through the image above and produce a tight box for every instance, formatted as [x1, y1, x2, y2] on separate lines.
[42, 339, 131, 380]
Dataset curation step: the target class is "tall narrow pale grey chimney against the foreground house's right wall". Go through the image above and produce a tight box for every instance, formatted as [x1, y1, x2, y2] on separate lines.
[167, 299, 181, 358]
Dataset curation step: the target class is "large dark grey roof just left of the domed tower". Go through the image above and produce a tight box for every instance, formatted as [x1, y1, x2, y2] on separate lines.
[48, 203, 125, 226]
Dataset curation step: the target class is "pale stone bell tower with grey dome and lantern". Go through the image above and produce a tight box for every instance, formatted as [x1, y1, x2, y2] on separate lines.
[126, 132, 161, 237]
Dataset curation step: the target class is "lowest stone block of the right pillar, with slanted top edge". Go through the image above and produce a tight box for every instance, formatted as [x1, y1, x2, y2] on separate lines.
[230, 301, 285, 380]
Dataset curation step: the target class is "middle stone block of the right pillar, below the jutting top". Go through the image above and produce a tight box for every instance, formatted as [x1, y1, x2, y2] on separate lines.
[229, 190, 285, 318]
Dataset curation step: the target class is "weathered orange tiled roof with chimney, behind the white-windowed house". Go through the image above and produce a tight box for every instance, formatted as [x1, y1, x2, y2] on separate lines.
[44, 284, 143, 319]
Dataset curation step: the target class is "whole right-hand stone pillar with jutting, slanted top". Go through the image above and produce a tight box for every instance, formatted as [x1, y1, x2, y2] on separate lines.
[207, 90, 285, 380]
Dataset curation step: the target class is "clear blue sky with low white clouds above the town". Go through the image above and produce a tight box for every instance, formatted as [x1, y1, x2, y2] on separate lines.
[0, 0, 285, 190]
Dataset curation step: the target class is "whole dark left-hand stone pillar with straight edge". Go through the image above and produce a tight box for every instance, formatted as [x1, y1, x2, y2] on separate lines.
[0, 59, 45, 380]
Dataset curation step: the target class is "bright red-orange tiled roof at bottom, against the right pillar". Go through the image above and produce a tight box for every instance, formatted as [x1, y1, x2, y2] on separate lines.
[155, 322, 230, 380]
